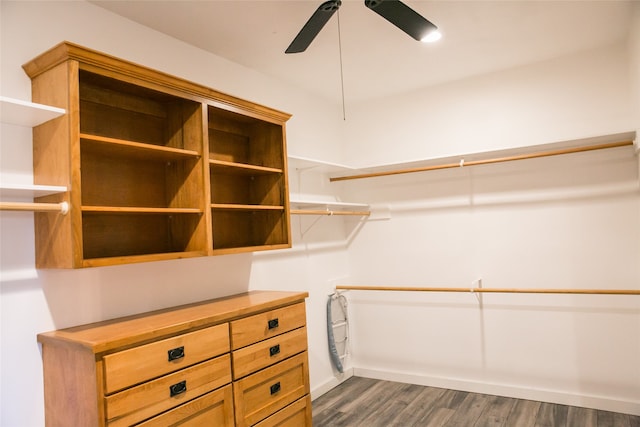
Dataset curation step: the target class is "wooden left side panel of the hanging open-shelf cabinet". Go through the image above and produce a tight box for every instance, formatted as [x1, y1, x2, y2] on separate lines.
[32, 62, 77, 268]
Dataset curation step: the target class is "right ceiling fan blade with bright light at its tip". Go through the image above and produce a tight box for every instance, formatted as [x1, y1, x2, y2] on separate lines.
[364, 0, 438, 40]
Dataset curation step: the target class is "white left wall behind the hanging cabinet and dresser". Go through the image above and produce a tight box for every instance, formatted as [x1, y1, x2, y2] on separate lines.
[0, 1, 347, 427]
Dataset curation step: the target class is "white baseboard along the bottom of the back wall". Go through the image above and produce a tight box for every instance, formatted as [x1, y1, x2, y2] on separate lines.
[352, 367, 640, 415]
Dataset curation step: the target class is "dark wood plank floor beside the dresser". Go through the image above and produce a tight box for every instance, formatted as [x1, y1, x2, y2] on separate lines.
[313, 377, 640, 427]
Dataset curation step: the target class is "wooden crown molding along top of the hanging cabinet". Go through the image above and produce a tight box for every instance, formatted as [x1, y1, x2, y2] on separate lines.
[22, 41, 291, 123]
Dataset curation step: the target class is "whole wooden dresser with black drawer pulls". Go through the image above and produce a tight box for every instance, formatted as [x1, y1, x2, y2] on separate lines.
[38, 291, 312, 427]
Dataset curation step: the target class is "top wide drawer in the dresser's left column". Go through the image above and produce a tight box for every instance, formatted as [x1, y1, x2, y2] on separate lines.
[104, 323, 229, 394]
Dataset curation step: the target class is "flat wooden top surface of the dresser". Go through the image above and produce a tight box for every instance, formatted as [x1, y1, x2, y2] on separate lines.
[38, 291, 309, 354]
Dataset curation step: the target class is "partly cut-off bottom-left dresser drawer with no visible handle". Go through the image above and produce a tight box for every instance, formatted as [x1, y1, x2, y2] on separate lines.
[136, 385, 233, 427]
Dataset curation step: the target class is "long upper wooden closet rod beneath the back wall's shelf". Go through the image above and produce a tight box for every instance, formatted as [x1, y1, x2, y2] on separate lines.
[329, 141, 633, 182]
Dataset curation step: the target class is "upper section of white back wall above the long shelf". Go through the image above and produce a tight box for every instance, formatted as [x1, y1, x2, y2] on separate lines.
[345, 44, 635, 166]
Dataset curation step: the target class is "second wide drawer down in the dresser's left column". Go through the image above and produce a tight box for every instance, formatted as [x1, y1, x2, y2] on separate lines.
[105, 354, 231, 427]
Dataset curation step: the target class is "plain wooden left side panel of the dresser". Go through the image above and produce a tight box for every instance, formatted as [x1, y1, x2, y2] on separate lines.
[42, 344, 102, 427]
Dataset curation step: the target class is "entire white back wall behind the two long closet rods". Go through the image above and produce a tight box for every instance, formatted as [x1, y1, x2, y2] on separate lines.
[342, 10, 640, 414]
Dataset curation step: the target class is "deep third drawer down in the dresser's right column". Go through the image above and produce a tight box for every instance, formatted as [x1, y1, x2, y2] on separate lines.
[233, 351, 309, 426]
